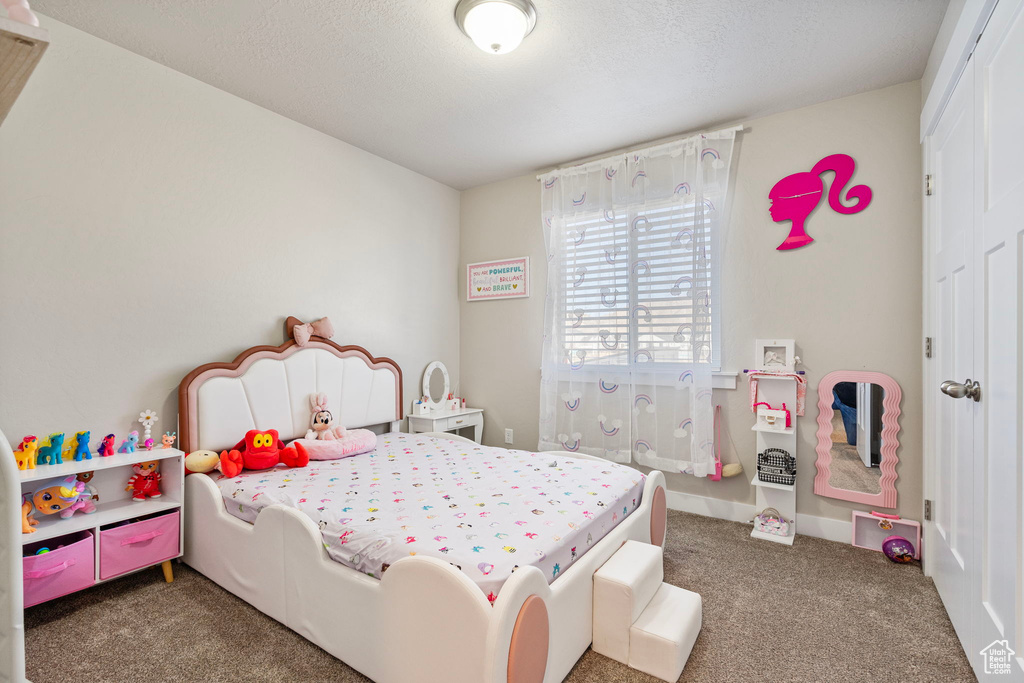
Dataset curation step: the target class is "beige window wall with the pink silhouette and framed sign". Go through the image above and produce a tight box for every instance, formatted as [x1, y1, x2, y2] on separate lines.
[460, 82, 922, 520]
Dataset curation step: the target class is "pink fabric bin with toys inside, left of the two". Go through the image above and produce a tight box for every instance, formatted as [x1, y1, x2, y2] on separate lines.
[22, 531, 96, 607]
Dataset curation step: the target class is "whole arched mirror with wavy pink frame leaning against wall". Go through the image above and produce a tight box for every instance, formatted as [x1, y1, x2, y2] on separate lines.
[814, 370, 902, 508]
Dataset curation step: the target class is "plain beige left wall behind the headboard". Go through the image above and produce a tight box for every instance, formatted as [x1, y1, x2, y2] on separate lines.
[0, 17, 459, 440]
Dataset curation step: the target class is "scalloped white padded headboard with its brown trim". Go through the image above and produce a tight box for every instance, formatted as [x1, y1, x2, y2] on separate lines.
[178, 337, 402, 452]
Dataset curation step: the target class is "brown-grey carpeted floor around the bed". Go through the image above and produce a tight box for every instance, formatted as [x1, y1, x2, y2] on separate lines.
[25, 511, 975, 683]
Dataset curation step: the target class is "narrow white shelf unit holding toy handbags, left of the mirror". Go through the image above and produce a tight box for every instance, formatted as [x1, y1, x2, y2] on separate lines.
[751, 339, 800, 546]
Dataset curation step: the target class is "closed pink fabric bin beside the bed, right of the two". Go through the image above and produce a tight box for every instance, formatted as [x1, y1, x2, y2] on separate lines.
[99, 510, 179, 579]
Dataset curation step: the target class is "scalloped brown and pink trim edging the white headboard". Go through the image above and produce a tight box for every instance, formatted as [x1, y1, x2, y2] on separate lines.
[178, 337, 404, 452]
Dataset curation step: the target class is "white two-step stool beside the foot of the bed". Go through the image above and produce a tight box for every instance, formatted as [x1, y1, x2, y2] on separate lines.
[593, 541, 701, 682]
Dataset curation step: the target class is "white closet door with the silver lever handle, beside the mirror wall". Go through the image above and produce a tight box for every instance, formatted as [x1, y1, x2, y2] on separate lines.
[926, 60, 981, 653]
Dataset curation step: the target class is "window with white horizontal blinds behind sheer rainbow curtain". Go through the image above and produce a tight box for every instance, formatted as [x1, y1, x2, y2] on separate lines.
[559, 196, 720, 372]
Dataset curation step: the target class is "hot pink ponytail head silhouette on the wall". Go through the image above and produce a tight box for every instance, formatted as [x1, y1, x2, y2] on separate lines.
[768, 155, 871, 251]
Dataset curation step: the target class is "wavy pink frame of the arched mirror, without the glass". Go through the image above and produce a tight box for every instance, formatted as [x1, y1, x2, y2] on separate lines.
[814, 370, 903, 508]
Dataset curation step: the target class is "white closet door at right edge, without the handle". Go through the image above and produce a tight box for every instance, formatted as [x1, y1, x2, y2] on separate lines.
[968, 0, 1024, 681]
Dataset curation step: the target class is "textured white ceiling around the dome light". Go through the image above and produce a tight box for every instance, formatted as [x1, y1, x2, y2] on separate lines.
[32, 0, 948, 189]
